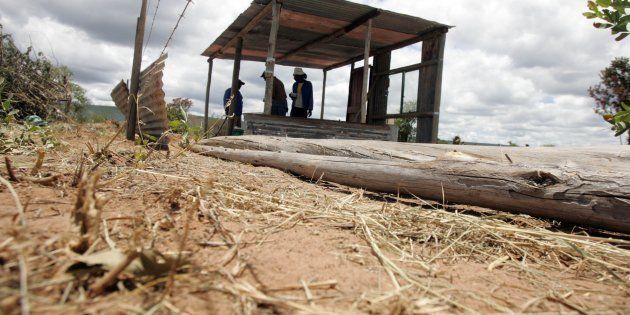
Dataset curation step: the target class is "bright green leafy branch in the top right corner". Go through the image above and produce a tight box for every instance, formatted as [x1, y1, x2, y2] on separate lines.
[584, 0, 630, 41]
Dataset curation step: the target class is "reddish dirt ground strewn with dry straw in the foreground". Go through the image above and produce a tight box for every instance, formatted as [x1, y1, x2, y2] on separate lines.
[0, 124, 630, 314]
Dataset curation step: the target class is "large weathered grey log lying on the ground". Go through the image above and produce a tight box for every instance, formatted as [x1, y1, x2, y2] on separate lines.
[193, 136, 630, 233]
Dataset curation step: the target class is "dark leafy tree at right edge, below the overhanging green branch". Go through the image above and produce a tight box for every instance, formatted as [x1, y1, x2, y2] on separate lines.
[589, 57, 630, 144]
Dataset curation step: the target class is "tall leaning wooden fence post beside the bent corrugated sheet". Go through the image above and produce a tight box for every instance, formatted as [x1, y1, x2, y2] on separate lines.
[127, 0, 147, 141]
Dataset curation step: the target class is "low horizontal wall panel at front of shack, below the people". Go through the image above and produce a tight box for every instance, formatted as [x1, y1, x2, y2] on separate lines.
[244, 114, 398, 141]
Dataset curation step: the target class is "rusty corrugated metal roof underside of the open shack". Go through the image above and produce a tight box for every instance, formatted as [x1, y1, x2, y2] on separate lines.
[203, 0, 449, 69]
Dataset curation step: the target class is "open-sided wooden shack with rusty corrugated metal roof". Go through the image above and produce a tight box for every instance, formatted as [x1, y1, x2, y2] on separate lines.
[203, 0, 450, 143]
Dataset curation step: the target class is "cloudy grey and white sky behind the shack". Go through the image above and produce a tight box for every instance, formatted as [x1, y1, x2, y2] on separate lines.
[0, 0, 630, 146]
